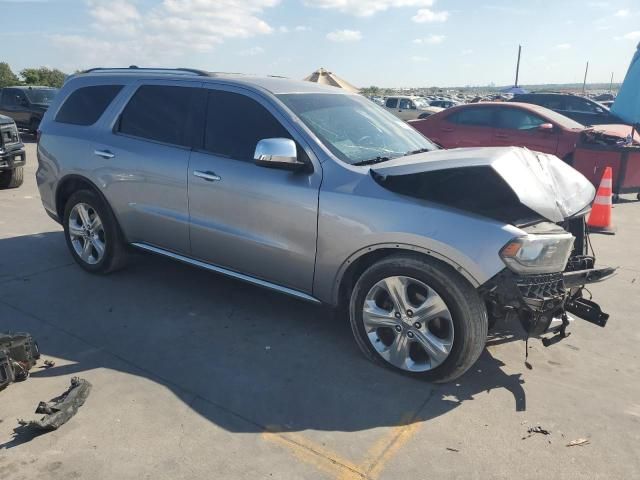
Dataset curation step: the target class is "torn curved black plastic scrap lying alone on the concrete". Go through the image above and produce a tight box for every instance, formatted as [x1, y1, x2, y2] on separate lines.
[19, 377, 91, 431]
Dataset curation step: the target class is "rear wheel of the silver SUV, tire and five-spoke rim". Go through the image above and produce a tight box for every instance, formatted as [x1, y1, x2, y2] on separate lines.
[63, 190, 126, 274]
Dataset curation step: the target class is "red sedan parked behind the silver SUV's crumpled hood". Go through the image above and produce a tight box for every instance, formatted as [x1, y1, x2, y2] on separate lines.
[409, 102, 586, 162]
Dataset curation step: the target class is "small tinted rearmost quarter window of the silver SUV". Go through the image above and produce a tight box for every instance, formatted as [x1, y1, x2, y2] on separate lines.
[56, 85, 122, 126]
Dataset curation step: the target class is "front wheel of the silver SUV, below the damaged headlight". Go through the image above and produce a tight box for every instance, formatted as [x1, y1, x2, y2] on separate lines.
[349, 254, 488, 382]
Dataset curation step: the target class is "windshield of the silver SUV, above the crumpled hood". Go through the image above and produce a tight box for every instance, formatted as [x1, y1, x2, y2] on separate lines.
[278, 93, 438, 165]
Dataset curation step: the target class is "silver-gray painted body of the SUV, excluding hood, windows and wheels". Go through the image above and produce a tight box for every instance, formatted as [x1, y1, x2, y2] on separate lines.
[37, 72, 580, 304]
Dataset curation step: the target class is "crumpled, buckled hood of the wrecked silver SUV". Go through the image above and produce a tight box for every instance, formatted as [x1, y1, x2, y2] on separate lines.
[371, 147, 595, 222]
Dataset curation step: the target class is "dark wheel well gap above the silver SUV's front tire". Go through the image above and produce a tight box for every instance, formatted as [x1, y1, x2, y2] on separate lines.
[337, 248, 473, 308]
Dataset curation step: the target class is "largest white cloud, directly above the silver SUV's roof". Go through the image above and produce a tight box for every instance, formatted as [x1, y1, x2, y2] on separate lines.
[49, 0, 280, 67]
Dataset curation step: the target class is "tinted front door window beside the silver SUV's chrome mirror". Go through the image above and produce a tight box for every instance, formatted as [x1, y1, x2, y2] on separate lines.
[204, 90, 291, 160]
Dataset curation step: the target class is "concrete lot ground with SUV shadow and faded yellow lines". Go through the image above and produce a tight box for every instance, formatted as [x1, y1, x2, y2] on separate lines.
[0, 137, 640, 480]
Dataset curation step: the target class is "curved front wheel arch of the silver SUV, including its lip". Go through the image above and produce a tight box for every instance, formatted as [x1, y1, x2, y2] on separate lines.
[331, 243, 480, 306]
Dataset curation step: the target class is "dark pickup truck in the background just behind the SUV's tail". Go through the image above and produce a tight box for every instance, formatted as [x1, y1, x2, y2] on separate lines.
[0, 86, 58, 134]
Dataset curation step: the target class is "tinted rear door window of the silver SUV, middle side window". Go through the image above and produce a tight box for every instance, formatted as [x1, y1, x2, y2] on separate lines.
[117, 85, 199, 147]
